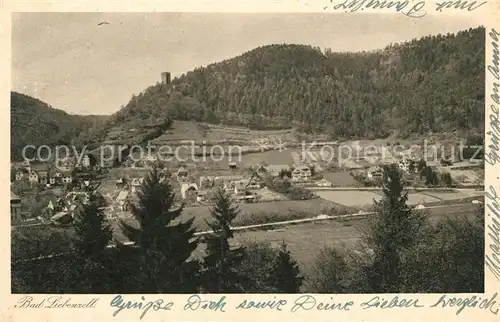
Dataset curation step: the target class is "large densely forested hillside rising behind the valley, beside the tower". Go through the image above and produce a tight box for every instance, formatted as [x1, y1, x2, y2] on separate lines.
[97, 27, 485, 141]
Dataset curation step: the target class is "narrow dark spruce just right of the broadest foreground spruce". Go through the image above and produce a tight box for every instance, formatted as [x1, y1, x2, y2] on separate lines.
[204, 189, 245, 293]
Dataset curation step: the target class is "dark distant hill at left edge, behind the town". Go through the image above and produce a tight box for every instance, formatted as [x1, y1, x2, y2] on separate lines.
[10, 92, 108, 160]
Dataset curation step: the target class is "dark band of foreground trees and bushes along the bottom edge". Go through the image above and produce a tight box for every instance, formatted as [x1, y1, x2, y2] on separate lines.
[12, 166, 484, 293]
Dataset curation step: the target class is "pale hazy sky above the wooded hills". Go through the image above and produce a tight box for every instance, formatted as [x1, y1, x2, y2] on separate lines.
[12, 13, 479, 114]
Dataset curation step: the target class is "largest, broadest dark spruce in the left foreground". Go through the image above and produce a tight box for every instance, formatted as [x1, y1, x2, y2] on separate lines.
[121, 167, 198, 293]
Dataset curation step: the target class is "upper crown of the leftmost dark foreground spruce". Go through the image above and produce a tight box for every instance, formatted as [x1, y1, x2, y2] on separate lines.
[74, 192, 113, 256]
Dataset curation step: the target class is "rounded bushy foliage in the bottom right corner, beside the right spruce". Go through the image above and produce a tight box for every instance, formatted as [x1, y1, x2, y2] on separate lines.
[402, 206, 484, 293]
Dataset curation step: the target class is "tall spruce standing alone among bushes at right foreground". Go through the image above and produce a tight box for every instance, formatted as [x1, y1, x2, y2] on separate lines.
[364, 164, 427, 293]
